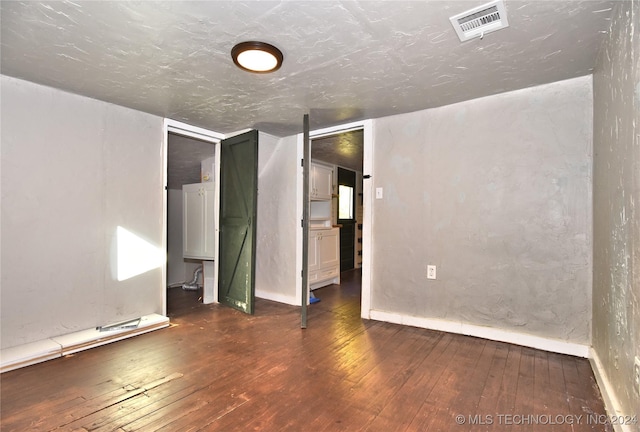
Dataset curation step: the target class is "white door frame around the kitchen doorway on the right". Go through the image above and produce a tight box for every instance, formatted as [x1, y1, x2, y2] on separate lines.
[296, 119, 374, 319]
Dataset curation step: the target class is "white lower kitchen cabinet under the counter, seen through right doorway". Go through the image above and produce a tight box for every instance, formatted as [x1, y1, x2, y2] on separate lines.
[309, 228, 340, 290]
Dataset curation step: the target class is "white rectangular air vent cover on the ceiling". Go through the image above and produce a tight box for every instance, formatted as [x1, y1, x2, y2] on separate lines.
[449, 0, 509, 42]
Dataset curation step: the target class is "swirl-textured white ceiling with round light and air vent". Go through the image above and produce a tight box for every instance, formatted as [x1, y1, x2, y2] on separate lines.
[0, 0, 615, 136]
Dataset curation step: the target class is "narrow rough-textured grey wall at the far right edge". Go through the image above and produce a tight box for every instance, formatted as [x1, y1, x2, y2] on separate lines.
[593, 1, 640, 418]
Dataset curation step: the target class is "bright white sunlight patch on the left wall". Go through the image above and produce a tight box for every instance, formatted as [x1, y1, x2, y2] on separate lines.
[116, 226, 165, 281]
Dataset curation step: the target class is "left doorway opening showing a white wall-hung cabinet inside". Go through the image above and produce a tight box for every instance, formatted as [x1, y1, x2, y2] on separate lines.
[163, 119, 222, 316]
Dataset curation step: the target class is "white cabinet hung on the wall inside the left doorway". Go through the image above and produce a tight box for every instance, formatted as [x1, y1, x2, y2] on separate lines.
[182, 182, 215, 260]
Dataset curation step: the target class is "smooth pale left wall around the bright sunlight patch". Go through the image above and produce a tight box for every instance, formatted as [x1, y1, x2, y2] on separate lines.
[0, 76, 164, 348]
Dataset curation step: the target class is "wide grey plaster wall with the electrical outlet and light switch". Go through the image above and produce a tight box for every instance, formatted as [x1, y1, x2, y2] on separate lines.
[372, 77, 592, 344]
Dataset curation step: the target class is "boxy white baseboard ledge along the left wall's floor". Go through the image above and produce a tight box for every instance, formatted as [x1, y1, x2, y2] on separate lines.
[0, 314, 169, 373]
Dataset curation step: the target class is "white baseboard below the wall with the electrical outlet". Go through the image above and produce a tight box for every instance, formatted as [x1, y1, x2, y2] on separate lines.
[370, 310, 589, 358]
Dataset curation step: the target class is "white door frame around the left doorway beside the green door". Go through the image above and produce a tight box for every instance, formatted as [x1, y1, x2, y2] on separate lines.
[162, 118, 226, 316]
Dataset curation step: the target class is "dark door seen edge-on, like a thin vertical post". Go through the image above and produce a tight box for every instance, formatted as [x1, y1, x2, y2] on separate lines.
[300, 114, 311, 328]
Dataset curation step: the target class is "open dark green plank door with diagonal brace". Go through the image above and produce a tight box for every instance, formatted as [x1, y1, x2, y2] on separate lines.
[218, 130, 258, 314]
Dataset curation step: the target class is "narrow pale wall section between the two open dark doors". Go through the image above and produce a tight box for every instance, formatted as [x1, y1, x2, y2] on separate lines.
[256, 132, 299, 304]
